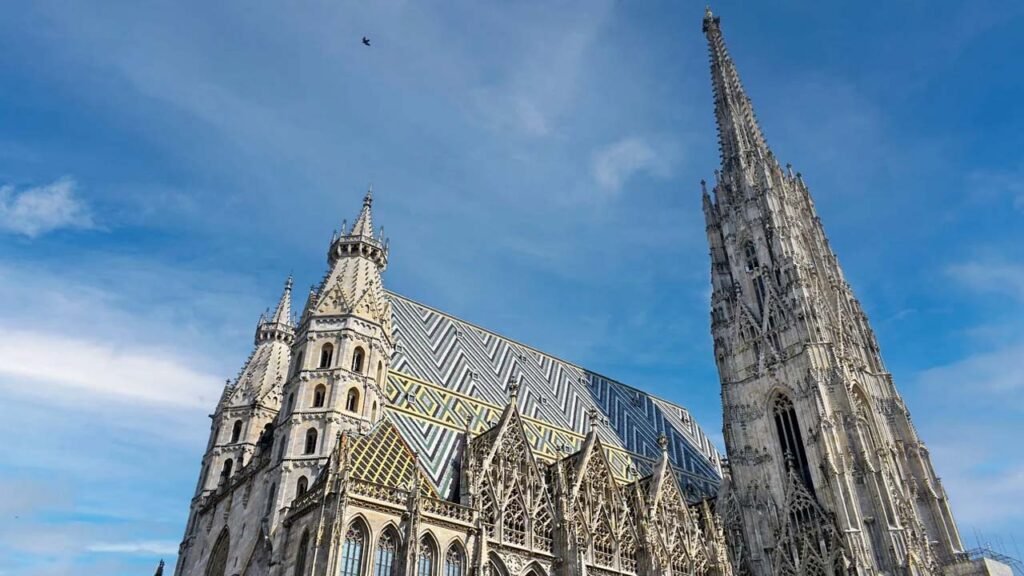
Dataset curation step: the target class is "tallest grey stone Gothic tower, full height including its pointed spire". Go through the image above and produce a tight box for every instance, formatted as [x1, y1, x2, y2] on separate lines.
[703, 10, 963, 576]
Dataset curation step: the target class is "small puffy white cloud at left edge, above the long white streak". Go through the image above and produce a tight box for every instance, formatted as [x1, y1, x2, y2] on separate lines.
[0, 178, 94, 238]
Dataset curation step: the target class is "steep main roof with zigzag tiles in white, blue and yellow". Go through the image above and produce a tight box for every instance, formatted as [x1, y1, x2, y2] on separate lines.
[385, 292, 721, 498]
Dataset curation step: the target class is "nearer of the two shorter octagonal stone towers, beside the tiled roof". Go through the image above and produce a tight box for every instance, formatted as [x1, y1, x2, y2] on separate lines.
[271, 192, 393, 521]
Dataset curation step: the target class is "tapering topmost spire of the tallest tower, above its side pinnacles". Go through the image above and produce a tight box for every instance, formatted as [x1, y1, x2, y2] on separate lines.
[703, 8, 771, 168]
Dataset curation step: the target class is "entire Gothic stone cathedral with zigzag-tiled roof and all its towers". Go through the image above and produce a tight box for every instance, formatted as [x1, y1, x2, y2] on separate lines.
[172, 10, 993, 576]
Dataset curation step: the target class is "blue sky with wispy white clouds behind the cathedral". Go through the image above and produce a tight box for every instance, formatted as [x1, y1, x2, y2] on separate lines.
[0, 0, 1024, 575]
